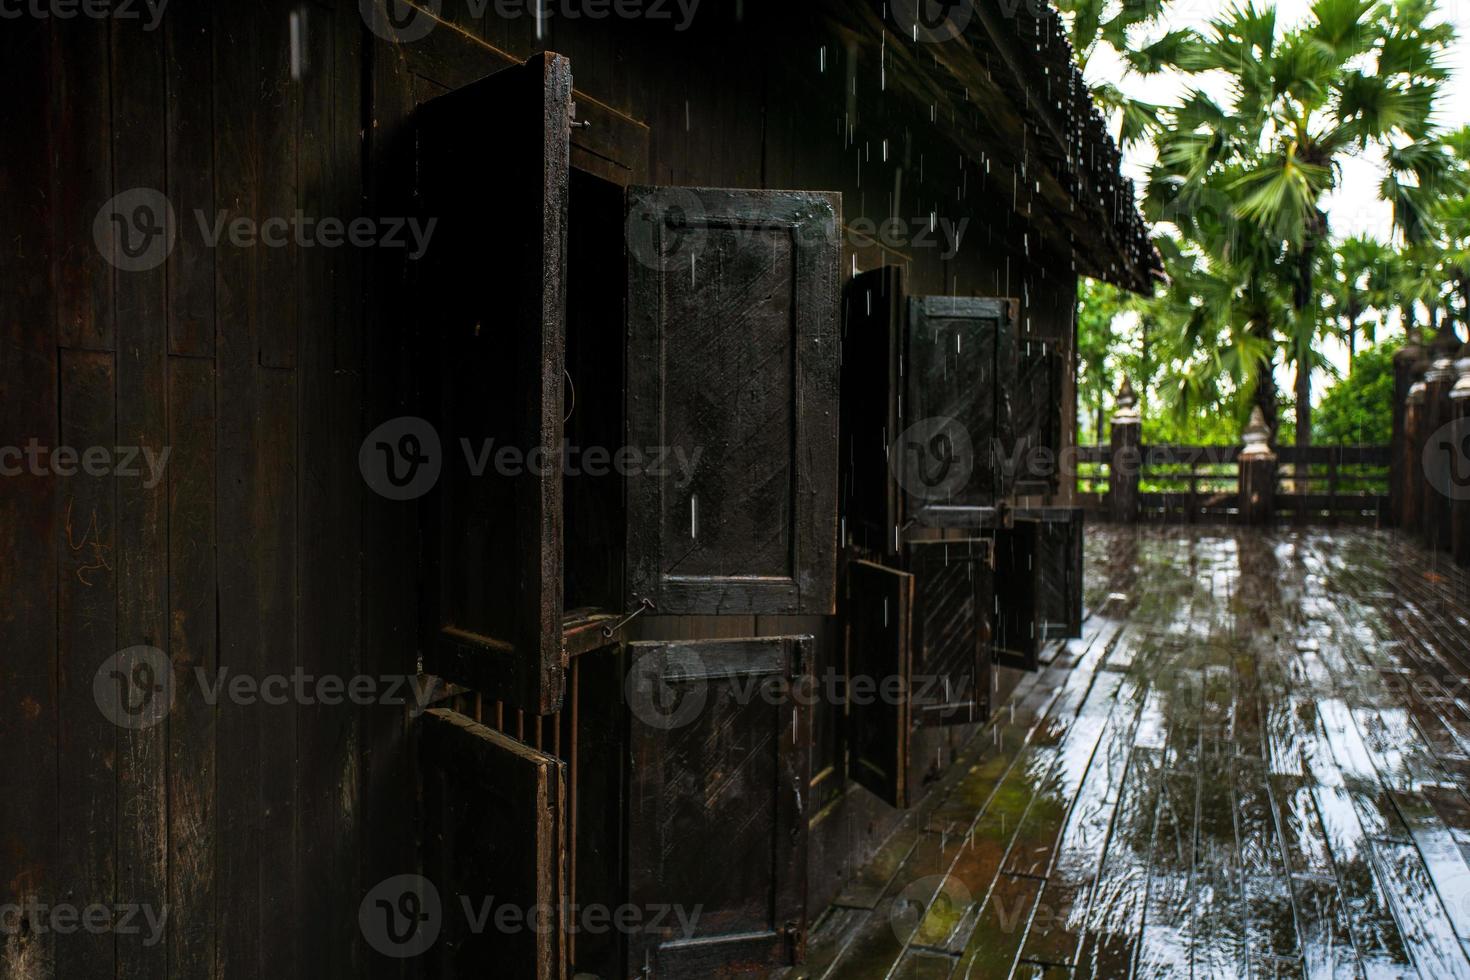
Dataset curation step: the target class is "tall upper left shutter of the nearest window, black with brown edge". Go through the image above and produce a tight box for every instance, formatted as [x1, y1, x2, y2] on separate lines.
[417, 53, 572, 714]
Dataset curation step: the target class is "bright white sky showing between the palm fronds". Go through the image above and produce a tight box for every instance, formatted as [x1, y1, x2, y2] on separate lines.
[1086, 0, 1470, 390]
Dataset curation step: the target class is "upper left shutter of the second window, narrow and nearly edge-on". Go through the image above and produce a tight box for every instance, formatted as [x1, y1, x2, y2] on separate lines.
[838, 266, 904, 555]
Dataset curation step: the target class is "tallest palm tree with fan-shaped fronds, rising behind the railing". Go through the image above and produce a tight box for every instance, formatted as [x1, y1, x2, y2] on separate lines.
[1151, 0, 1448, 467]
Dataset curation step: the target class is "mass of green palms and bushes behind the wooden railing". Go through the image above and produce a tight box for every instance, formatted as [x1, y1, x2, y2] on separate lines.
[1060, 0, 1470, 442]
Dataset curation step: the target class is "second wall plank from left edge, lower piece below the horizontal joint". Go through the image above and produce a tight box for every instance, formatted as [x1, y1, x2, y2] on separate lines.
[54, 348, 118, 977]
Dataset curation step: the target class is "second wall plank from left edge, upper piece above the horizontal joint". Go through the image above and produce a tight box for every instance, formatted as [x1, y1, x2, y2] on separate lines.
[51, 18, 116, 351]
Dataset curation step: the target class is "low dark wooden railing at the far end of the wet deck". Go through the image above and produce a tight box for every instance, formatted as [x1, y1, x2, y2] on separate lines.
[1078, 445, 1391, 526]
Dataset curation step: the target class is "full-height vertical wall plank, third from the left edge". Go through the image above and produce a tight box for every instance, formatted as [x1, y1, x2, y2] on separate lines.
[110, 11, 168, 979]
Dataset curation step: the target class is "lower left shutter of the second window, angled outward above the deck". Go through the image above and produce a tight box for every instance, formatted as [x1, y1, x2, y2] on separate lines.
[842, 561, 914, 807]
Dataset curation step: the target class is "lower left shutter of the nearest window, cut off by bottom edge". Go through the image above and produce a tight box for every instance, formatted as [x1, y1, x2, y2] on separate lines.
[419, 708, 566, 979]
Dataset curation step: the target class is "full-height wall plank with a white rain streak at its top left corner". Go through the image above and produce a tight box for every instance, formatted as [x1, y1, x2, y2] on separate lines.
[295, 4, 360, 976]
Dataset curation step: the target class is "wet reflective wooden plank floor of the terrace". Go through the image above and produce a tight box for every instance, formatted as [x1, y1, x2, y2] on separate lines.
[791, 527, 1470, 980]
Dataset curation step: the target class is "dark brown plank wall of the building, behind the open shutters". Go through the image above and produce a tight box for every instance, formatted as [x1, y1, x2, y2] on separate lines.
[0, 0, 1076, 977]
